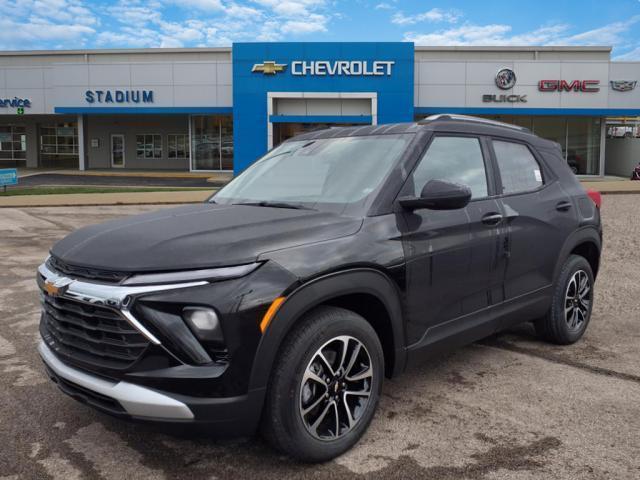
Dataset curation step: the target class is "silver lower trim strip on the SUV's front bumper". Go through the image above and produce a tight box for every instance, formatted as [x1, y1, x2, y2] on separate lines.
[38, 342, 194, 420]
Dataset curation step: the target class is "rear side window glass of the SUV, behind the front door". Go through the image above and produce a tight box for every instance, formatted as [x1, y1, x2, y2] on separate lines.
[493, 140, 543, 194]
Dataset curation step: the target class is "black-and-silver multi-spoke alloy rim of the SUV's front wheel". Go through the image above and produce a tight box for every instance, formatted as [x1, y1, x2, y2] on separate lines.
[299, 335, 374, 441]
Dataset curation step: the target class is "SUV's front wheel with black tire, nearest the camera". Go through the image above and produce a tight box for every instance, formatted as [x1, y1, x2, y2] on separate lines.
[261, 306, 384, 462]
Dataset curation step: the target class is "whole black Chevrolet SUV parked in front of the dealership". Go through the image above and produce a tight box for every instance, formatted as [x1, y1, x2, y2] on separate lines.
[38, 115, 602, 461]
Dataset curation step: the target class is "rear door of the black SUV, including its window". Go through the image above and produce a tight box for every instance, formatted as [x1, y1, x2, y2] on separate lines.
[491, 138, 578, 301]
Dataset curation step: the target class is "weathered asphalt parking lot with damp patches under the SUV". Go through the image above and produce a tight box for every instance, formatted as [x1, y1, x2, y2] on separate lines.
[0, 195, 640, 480]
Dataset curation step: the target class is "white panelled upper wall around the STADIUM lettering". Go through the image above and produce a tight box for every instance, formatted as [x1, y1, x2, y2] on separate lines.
[0, 49, 232, 115]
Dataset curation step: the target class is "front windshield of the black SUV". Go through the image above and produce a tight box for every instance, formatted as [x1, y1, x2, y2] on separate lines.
[213, 134, 413, 210]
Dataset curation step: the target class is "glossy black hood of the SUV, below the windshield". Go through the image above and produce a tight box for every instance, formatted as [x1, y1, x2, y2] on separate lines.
[51, 204, 362, 272]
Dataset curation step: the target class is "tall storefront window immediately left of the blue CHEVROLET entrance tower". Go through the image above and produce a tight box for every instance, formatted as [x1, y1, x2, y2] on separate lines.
[191, 115, 233, 170]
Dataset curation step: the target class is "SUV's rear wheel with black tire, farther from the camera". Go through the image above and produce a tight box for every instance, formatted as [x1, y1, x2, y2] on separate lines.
[534, 255, 594, 345]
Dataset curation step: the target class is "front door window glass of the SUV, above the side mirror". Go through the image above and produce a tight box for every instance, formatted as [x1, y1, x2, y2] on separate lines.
[413, 136, 488, 198]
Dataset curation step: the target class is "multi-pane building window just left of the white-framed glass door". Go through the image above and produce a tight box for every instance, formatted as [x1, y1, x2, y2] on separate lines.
[40, 122, 79, 168]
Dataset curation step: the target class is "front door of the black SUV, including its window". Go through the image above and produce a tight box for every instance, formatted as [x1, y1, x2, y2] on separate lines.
[400, 134, 504, 349]
